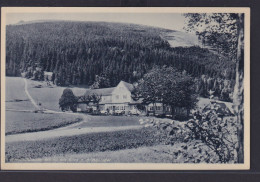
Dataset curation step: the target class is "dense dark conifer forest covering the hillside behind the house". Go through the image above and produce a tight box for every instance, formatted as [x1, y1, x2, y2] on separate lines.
[6, 21, 235, 100]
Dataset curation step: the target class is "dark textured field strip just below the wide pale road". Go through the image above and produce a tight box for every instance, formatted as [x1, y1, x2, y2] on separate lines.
[6, 128, 163, 162]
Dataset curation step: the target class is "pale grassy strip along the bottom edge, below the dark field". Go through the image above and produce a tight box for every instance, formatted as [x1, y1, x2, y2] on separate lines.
[17, 142, 217, 163]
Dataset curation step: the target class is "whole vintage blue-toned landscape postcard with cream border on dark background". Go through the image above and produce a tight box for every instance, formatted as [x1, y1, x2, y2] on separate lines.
[1, 7, 250, 170]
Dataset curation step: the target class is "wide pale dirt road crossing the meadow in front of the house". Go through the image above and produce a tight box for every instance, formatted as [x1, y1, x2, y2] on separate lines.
[5, 123, 142, 143]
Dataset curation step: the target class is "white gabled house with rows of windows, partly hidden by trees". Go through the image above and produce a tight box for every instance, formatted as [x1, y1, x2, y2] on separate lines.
[77, 81, 178, 115]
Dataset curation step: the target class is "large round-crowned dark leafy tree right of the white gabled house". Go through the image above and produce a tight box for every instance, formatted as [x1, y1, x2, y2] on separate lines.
[133, 66, 197, 116]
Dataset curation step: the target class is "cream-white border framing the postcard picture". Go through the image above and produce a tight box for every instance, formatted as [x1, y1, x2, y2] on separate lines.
[1, 7, 250, 170]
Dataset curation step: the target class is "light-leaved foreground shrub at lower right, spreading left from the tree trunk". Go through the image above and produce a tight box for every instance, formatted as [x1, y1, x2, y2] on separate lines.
[140, 108, 237, 163]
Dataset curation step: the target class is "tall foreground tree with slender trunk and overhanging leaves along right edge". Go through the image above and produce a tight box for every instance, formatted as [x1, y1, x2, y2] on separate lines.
[185, 13, 244, 163]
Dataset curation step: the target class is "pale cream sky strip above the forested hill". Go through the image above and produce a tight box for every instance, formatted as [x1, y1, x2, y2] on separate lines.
[6, 13, 185, 31]
